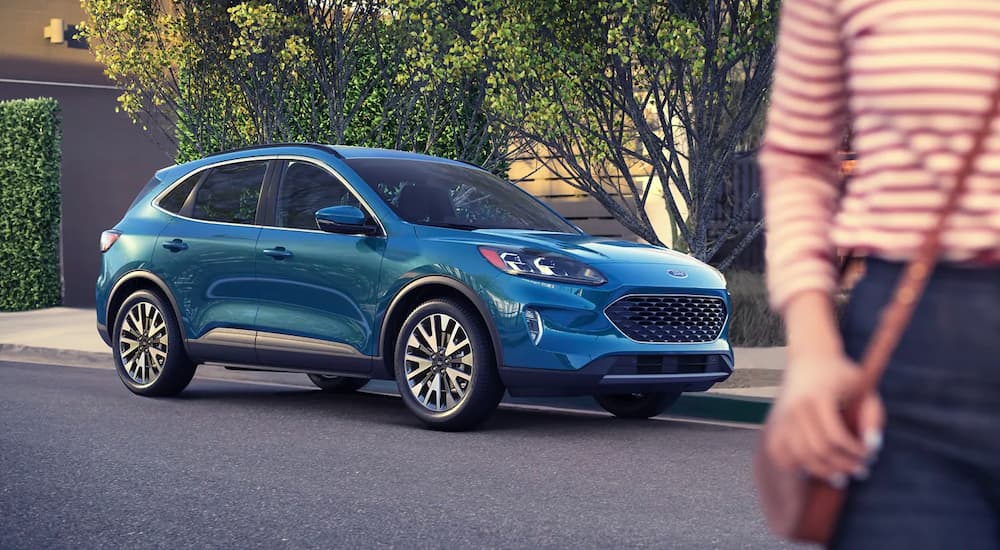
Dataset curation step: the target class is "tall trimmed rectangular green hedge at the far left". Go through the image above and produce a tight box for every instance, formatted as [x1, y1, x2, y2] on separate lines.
[0, 98, 62, 311]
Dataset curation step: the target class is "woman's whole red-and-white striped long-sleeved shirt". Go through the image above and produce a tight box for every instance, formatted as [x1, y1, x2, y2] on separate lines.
[760, 0, 1000, 310]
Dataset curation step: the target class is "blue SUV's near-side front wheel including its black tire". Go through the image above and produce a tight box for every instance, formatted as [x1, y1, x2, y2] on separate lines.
[393, 299, 504, 431]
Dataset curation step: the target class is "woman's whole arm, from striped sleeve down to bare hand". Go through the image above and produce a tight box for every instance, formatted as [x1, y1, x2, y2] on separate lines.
[760, 0, 882, 484]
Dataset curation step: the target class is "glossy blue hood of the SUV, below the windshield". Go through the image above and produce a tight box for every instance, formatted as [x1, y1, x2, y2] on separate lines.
[475, 229, 705, 268]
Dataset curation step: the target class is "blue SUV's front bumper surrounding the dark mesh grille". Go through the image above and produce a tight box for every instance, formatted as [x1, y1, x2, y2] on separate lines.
[484, 268, 734, 396]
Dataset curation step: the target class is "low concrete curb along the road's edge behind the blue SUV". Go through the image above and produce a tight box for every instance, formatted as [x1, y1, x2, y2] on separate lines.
[0, 343, 771, 424]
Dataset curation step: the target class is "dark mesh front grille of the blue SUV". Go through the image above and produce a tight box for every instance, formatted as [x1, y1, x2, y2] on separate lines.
[604, 295, 726, 344]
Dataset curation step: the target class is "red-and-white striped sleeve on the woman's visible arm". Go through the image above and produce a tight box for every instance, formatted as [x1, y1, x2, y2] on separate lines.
[760, 0, 847, 311]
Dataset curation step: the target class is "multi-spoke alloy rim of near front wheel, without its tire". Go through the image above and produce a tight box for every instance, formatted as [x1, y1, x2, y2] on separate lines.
[404, 313, 475, 412]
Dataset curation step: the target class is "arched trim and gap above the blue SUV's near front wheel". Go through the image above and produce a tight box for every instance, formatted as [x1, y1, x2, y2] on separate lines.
[376, 275, 503, 377]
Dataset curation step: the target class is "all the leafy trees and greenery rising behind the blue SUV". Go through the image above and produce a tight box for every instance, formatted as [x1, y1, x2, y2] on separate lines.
[81, 0, 778, 267]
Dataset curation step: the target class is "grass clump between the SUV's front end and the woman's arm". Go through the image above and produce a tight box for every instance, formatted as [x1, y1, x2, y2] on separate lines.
[726, 271, 785, 347]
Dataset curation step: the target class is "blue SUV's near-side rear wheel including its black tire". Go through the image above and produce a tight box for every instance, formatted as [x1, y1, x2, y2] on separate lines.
[111, 290, 197, 397]
